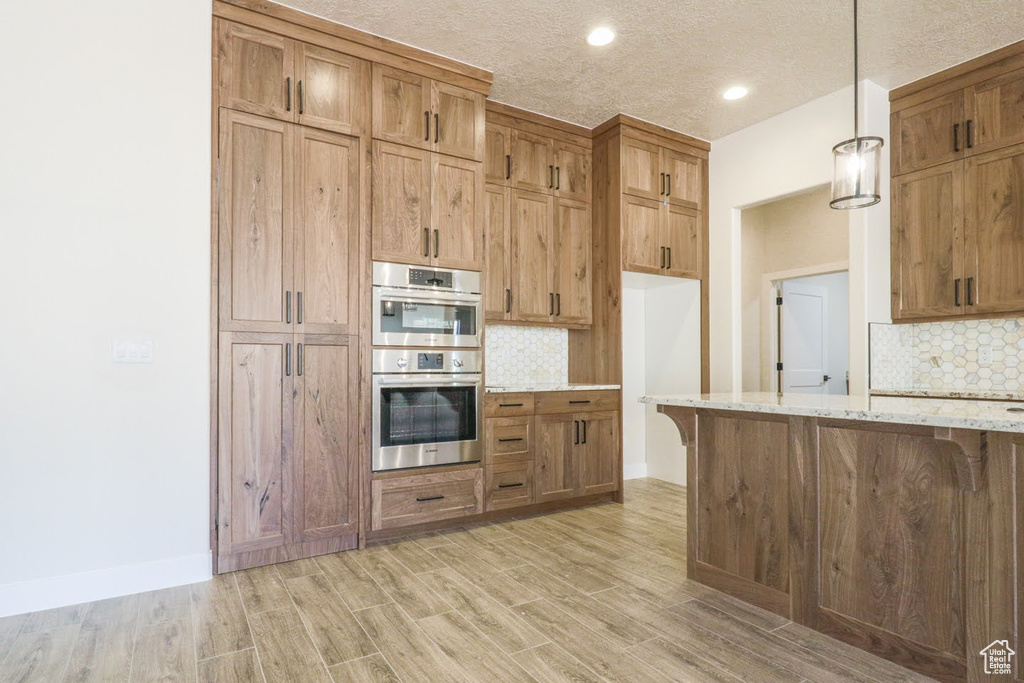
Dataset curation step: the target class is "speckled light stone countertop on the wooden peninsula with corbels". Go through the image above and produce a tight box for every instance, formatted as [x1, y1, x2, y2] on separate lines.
[640, 392, 1024, 433]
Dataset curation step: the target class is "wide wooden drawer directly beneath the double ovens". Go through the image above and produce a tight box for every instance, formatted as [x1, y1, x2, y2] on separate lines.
[372, 468, 483, 530]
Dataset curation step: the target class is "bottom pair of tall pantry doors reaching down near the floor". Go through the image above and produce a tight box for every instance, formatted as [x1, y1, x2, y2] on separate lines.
[217, 333, 359, 570]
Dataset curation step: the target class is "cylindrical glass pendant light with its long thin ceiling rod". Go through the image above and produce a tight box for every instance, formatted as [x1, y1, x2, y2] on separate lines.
[829, 0, 885, 209]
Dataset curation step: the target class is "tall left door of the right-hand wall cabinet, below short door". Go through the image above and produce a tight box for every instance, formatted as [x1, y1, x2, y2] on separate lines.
[892, 162, 965, 319]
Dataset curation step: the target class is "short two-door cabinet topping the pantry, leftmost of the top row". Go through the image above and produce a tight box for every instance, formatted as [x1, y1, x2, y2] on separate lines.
[217, 19, 370, 135]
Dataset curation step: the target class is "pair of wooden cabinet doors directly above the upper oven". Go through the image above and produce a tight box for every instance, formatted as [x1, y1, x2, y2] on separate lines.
[372, 140, 485, 270]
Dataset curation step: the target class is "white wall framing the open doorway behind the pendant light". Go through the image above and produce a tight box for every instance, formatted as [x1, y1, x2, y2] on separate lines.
[710, 81, 889, 393]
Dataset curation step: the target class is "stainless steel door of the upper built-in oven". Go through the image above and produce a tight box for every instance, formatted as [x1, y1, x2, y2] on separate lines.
[373, 287, 483, 347]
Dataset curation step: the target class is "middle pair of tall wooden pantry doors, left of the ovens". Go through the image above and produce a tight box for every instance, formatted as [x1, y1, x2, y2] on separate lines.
[218, 110, 362, 335]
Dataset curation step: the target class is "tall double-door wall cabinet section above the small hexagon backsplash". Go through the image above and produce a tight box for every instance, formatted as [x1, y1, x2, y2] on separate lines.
[503, 189, 593, 327]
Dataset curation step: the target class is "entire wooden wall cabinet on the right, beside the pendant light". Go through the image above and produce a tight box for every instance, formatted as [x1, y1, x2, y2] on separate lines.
[890, 44, 1024, 322]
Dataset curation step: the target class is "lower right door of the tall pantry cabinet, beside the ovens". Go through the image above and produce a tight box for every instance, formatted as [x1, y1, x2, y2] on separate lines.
[293, 335, 360, 543]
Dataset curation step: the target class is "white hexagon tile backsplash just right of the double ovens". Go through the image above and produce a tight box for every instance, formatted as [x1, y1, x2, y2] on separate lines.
[483, 325, 569, 386]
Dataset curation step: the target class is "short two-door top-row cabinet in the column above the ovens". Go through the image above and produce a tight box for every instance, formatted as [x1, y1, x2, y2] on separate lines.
[373, 65, 484, 161]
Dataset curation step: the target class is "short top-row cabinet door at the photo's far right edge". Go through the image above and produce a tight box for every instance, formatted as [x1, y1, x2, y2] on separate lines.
[964, 69, 1024, 155]
